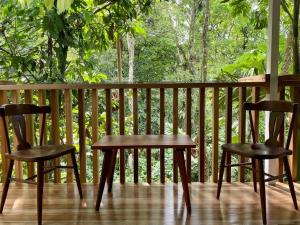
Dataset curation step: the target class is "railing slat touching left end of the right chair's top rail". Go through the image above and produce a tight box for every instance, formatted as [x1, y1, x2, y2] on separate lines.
[239, 87, 246, 183]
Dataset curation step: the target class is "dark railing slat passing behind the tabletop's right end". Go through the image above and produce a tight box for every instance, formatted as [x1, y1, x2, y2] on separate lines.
[186, 88, 192, 183]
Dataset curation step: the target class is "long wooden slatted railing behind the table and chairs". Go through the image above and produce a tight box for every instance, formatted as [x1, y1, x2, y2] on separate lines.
[0, 77, 297, 183]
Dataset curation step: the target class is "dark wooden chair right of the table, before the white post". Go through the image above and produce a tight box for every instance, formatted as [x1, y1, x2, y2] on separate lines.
[217, 101, 298, 224]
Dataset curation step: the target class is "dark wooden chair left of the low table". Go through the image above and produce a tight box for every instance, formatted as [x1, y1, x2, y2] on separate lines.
[0, 104, 83, 225]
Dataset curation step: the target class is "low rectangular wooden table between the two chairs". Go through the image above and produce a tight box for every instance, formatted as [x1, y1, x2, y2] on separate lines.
[92, 135, 196, 213]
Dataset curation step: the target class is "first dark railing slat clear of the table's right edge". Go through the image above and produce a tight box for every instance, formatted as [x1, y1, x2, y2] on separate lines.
[199, 88, 205, 183]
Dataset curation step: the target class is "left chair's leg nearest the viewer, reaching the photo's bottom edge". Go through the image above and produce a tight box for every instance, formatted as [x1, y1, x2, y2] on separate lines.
[37, 161, 44, 225]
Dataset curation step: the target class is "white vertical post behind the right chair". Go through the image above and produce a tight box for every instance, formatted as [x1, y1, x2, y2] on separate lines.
[265, 0, 280, 179]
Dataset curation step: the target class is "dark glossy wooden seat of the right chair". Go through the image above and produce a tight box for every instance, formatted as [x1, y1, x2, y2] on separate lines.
[222, 143, 292, 159]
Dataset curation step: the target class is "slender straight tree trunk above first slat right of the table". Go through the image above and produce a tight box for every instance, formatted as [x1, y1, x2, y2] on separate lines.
[201, 0, 210, 82]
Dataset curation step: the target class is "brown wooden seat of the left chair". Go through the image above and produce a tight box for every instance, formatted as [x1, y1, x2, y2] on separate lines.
[6, 145, 75, 162]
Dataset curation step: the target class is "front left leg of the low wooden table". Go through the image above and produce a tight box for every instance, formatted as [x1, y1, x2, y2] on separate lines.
[96, 150, 112, 211]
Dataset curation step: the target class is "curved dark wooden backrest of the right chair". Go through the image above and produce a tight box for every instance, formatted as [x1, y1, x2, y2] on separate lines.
[244, 101, 297, 149]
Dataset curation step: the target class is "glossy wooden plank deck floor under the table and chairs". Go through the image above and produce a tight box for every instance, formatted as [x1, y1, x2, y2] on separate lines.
[0, 183, 300, 225]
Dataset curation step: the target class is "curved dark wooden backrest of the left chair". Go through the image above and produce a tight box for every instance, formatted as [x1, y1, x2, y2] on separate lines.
[0, 104, 51, 153]
